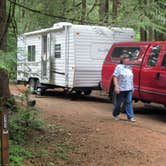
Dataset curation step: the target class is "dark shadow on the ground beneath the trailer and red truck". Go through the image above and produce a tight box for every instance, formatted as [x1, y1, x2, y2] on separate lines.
[36, 91, 166, 122]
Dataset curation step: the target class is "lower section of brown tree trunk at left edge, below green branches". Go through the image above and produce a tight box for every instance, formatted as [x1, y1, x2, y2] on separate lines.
[0, 68, 10, 102]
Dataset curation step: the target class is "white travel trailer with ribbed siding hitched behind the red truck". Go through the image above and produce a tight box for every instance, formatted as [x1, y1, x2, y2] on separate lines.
[17, 22, 135, 94]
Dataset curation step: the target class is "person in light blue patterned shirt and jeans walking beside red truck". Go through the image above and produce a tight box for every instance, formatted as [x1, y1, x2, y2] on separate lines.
[113, 54, 136, 122]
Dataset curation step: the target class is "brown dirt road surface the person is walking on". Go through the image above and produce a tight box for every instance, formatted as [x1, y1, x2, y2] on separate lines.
[11, 85, 166, 166]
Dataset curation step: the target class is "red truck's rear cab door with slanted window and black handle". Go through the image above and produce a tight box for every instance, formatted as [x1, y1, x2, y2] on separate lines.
[140, 43, 163, 102]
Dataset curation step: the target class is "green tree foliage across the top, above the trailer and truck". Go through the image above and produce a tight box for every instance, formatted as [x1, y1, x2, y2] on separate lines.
[13, 0, 166, 33]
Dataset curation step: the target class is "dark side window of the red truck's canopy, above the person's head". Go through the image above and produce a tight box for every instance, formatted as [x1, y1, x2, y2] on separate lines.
[111, 47, 141, 59]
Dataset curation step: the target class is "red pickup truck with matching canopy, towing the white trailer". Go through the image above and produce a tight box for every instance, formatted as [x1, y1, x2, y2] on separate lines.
[101, 41, 166, 106]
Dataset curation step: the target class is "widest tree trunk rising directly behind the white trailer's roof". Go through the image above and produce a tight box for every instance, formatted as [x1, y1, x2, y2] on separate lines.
[99, 0, 109, 23]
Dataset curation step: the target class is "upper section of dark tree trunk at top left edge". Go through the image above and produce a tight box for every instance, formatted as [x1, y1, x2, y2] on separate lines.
[0, 0, 6, 50]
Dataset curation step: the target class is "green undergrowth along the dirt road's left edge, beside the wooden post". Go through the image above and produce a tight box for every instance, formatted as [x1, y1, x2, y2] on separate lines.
[8, 93, 43, 166]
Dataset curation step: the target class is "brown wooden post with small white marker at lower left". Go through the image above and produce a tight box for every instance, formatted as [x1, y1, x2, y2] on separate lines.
[0, 110, 9, 166]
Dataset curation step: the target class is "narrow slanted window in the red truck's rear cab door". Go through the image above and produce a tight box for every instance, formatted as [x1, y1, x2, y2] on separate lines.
[148, 45, 161, 66]
